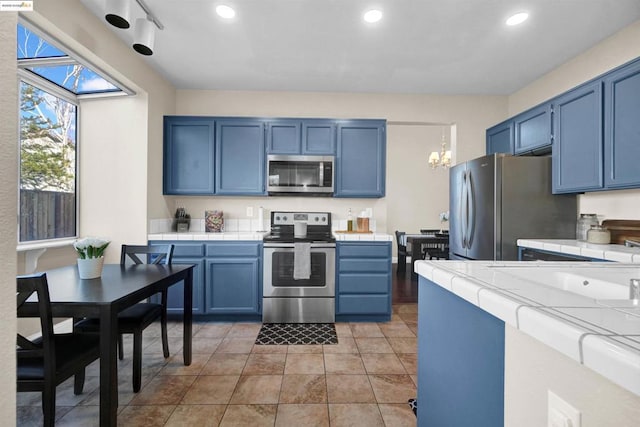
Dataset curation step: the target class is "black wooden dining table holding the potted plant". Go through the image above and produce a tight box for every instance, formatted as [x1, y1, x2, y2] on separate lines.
[22, 264, 194, 426]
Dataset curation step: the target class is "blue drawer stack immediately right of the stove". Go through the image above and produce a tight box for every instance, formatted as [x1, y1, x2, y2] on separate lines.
[336, 242, 391, 322]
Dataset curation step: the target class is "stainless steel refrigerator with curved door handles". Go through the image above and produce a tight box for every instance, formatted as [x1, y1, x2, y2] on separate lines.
[449, 154, 577, 260]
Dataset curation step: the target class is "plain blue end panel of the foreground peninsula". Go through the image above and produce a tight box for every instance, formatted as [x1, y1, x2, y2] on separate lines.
[417, 277, 505, 427]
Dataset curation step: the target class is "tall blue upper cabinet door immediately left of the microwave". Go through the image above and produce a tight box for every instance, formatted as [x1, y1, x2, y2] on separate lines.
[216, 119, 266, 195]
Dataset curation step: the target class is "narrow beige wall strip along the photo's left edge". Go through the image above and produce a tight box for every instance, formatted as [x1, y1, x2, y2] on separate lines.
[0, 12, 18, 426]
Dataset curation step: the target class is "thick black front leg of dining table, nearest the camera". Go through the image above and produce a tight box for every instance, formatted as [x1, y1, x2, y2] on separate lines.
[100, 306, 118, 427]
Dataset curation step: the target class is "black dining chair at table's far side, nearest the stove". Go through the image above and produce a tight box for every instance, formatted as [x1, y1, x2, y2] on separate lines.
[75, 244, 174, 393]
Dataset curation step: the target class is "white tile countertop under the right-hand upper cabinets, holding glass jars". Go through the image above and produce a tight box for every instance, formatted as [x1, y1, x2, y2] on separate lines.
[518, 239, 640, 263]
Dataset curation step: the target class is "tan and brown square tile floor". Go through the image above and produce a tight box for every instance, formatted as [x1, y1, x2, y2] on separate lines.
[17, 304, 418, 427]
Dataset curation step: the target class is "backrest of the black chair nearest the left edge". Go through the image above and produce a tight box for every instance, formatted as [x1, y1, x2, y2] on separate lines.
[16, 273, 56, 373]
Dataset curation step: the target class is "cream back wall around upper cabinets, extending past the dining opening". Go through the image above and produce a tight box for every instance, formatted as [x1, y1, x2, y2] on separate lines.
[162, 90, 507, 244]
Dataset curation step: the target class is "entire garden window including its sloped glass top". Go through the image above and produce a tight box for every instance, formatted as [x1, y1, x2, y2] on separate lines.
[17, 23, 132, 244]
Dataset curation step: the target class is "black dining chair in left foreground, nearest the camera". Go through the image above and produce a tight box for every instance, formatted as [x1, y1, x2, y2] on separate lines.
[16, 273, 100, 426]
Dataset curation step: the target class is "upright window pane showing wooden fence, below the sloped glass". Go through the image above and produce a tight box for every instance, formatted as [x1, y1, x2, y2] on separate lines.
[19, 81, 78, 242]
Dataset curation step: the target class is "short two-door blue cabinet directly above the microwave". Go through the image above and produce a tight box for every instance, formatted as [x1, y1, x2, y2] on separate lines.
[267, 119, 336, 155]
